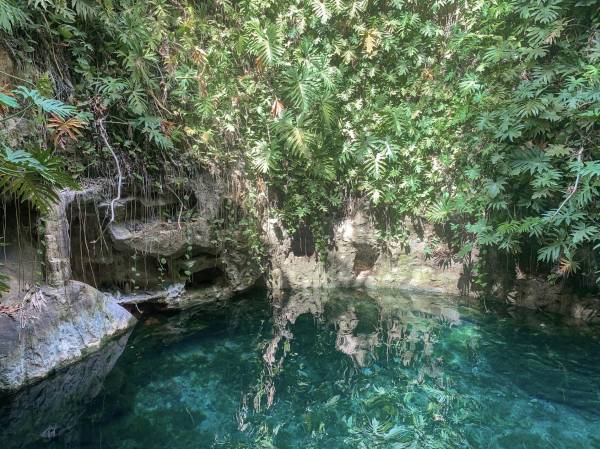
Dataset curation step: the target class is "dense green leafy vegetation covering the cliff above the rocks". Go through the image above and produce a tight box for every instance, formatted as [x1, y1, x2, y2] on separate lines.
[0, 0, 600, 287]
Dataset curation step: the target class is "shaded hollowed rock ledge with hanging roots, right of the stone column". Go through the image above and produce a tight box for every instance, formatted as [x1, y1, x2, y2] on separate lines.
[66, 173, 262, 308]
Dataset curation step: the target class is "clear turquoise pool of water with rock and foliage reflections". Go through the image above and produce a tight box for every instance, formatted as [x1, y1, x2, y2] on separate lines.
[0, 291, 600, 449]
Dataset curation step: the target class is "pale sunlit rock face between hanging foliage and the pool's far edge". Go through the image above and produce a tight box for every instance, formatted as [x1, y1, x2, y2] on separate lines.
[265, 212, 463, 293]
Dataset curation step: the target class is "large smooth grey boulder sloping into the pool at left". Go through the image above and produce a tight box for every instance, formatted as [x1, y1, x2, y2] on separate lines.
[0, 281, 136, 393]
